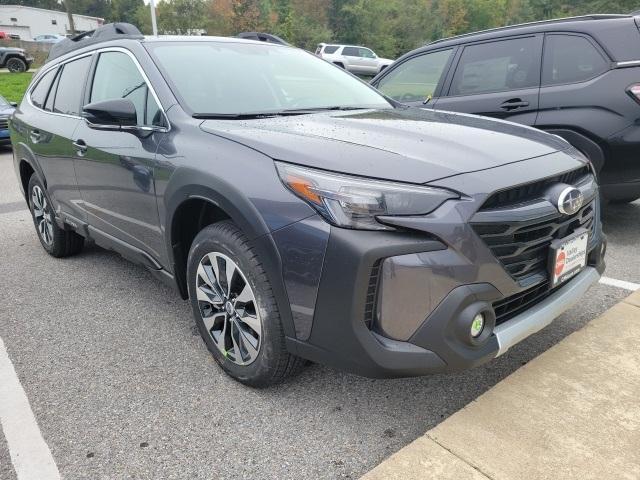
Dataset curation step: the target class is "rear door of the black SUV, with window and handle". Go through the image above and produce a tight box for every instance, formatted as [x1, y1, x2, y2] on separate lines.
[435, 35, 543, 125]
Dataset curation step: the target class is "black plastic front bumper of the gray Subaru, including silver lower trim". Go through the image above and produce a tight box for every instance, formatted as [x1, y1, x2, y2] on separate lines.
[287, 229, 606, 378]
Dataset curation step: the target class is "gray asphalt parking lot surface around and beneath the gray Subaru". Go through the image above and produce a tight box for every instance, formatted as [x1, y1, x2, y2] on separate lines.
[0, 149, 640, 480]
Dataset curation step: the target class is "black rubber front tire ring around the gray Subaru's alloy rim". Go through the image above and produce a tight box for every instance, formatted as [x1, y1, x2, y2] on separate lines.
[187, 222, 282, 386]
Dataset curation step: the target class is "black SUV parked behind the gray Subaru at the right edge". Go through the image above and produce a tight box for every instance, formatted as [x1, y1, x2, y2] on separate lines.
[372, 15, 640, 202]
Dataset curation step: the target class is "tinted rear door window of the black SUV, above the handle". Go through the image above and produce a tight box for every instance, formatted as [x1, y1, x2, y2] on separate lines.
[449, 37, 540, 95]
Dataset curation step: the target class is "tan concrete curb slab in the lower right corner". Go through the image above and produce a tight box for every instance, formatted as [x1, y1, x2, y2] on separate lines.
[362, 291, 640, 480]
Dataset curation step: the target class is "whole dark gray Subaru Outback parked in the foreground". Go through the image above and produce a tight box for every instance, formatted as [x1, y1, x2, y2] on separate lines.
[11, 24, 605, 386]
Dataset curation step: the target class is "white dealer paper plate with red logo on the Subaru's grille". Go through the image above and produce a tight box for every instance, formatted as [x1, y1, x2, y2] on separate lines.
[549, 228, 589, 288]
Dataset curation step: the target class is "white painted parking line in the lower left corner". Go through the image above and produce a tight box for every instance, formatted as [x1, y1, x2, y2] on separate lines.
[0, 338, 60, 480]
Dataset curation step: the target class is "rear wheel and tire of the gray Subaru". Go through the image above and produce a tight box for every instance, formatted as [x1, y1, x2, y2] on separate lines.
[27, 174, 84, 258]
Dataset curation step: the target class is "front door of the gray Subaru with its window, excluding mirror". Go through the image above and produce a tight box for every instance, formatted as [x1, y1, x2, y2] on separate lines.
[74, 51, 164, 259]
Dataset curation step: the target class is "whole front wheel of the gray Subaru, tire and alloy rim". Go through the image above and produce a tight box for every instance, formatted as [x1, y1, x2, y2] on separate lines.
[187, 221, 304, 387]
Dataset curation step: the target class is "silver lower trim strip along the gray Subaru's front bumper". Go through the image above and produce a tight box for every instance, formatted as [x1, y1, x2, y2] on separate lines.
[494, 267, 600, 357]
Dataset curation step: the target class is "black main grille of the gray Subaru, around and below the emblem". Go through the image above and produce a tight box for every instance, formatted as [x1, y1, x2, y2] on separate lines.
[473, 201, 595, 283]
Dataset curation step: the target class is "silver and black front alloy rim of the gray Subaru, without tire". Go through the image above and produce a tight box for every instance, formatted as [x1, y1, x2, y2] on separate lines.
[196, 252, 262, 365]
